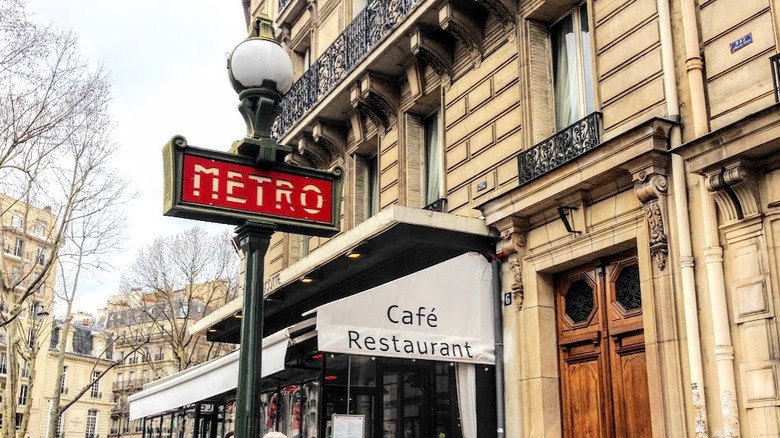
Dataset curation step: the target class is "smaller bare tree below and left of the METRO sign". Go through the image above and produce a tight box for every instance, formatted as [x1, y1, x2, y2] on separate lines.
[115, 227, 240, 376]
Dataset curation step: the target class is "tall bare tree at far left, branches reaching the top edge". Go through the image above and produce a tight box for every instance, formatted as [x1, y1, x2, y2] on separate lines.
[0, 0, 127, 438]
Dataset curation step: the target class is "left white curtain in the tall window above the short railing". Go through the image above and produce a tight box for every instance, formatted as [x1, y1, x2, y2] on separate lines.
[550, 15, 580, 131]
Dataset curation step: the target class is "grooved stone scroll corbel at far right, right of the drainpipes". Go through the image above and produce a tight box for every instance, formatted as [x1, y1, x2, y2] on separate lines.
[705, 159, 761, 224]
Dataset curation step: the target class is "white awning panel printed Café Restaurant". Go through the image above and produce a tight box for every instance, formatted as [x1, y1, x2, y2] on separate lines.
[316, 253, 495, 364]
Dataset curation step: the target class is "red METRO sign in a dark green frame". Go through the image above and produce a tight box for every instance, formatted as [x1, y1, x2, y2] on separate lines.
[163, 136, 343, 237]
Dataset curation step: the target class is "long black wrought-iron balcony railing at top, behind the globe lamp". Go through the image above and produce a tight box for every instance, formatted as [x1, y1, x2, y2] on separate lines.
[271, 0, 423, 138]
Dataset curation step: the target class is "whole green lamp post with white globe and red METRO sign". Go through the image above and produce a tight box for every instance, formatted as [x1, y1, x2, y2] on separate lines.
[163, 13, 343, 438]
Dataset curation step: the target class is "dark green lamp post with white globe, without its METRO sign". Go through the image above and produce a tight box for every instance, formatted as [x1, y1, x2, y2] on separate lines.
[228, 17, 293, 438]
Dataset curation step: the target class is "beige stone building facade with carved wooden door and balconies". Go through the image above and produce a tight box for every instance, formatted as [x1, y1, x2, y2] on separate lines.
[137, 0, 780, 437]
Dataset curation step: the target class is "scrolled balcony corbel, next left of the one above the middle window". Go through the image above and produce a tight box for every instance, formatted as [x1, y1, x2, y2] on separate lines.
[349, 72, 399, 132]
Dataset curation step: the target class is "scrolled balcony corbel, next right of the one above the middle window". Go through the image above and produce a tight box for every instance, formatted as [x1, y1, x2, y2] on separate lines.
[439, 0, 486, 67]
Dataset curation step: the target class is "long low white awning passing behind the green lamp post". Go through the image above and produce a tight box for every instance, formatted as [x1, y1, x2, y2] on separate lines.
[128, 328, 290, 420]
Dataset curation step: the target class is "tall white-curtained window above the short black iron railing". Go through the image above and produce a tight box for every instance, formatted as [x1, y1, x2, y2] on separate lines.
[550, 3, 595, 131]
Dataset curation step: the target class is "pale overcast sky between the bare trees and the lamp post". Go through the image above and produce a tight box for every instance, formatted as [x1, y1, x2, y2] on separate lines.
[28, 0, 246, 312]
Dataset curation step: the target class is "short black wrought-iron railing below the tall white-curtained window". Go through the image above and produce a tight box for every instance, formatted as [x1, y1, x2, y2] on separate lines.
[517, 113, 601, 185]
